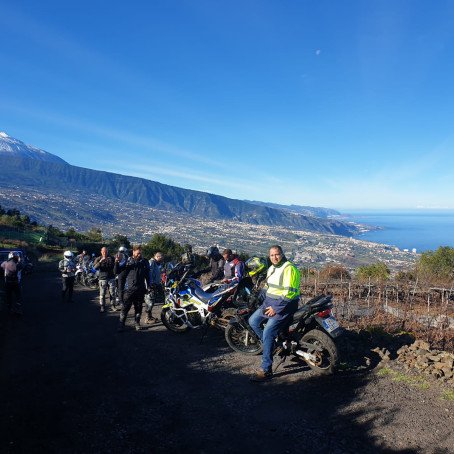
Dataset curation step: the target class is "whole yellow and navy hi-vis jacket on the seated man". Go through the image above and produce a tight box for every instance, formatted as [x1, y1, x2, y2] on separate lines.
[263, 259, 301, 319]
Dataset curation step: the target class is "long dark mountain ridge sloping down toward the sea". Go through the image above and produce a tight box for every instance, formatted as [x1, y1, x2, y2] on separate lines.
[0, 131, 358, 235]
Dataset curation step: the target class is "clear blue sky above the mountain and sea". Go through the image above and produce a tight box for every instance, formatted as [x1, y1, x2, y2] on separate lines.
[0, 0, 454, 211]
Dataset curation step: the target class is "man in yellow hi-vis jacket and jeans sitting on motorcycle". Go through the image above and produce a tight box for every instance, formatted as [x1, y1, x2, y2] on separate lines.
[249, 246, 301, 382]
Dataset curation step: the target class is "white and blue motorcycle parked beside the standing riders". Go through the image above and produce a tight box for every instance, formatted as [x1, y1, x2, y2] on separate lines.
[161, 267, 243, 333]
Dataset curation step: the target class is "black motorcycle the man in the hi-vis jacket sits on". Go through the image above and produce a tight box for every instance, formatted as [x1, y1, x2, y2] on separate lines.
[225, 295, 342, 375]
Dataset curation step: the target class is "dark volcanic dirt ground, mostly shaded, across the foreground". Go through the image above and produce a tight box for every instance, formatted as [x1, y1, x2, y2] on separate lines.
[0, 273, 454, 453]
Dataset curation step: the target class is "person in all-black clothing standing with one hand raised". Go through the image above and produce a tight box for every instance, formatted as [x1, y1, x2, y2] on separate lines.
[114, 245, 150, 331]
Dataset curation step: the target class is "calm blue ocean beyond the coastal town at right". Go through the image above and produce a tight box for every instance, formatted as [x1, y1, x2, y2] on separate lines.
[343, 210, 454, 252]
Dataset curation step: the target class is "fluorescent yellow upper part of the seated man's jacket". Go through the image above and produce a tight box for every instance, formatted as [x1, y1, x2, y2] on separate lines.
[266, 262, 301, 300]
